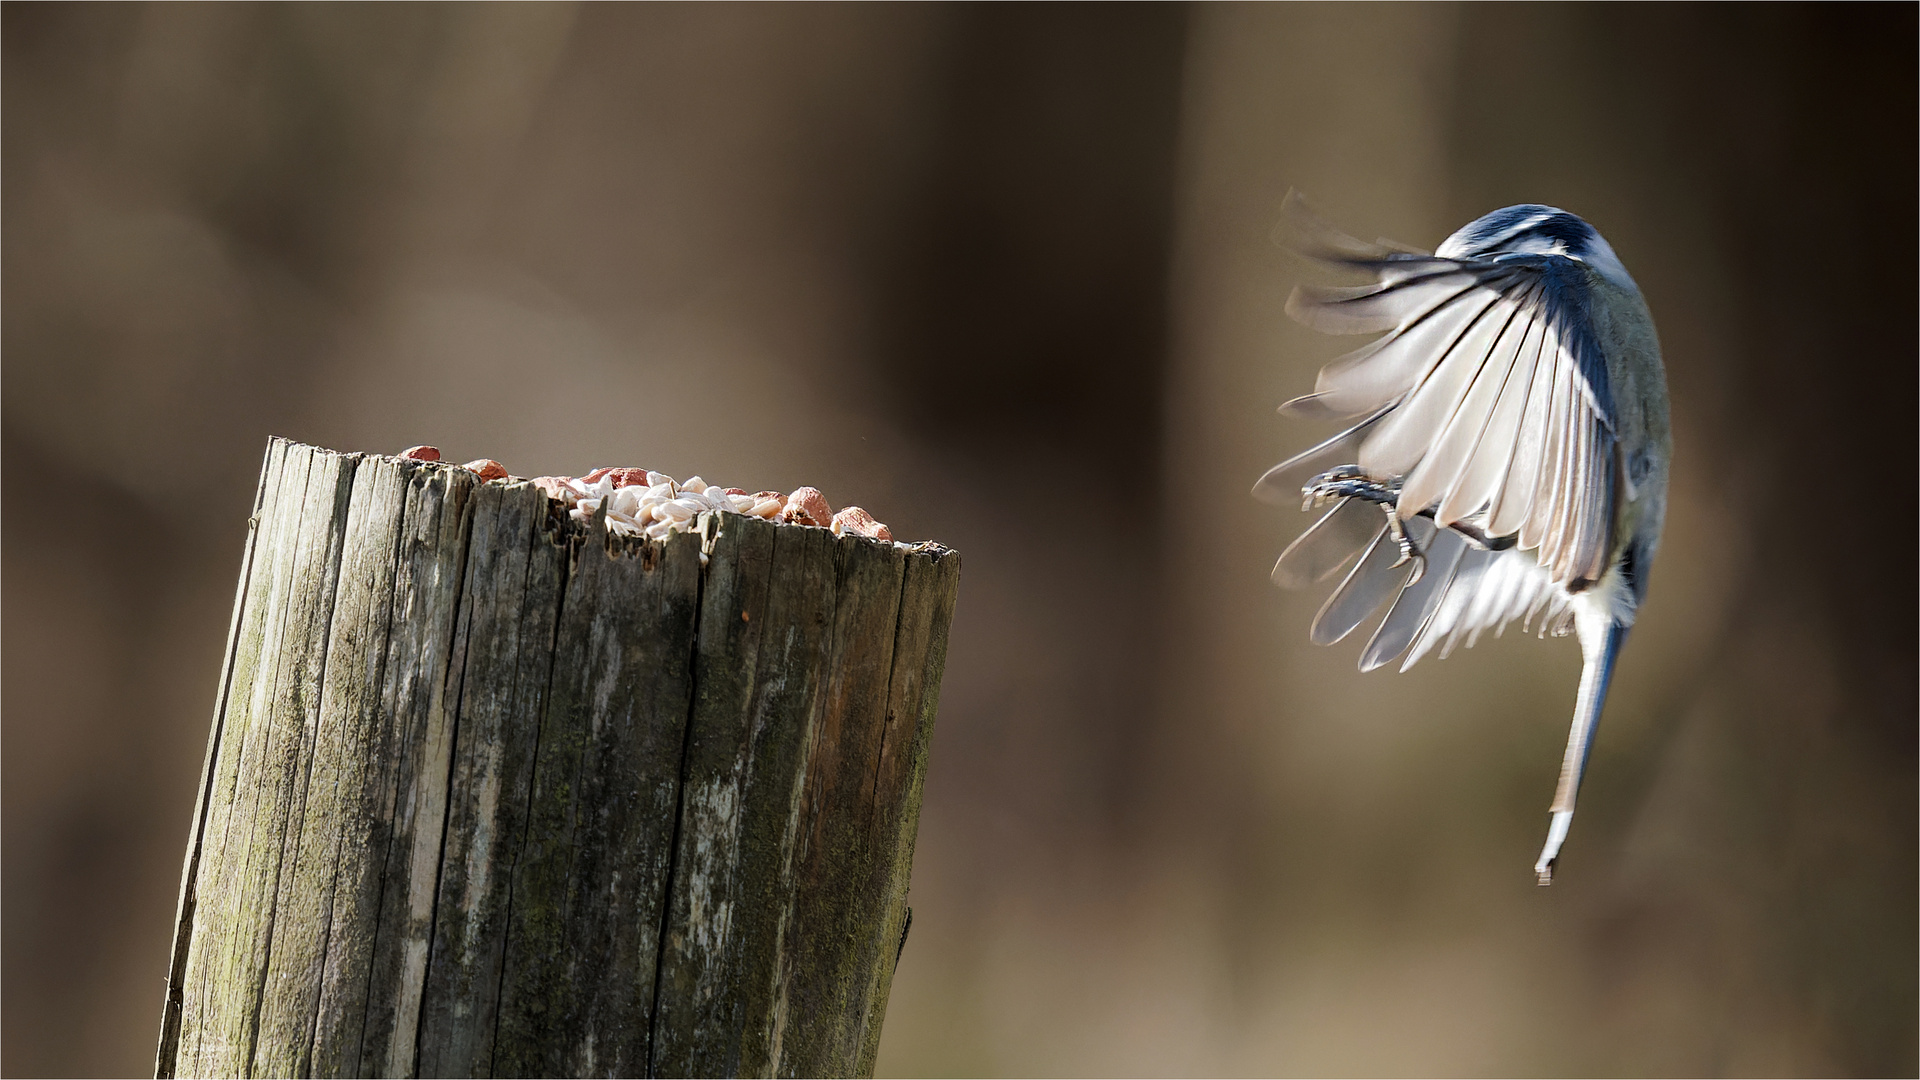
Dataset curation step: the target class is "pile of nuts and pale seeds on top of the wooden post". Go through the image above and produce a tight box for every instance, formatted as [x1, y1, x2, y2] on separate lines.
[401, 446, 893, 540]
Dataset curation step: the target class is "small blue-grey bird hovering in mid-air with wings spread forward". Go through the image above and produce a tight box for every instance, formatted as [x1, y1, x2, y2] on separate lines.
[1254, 192, 1672, 886]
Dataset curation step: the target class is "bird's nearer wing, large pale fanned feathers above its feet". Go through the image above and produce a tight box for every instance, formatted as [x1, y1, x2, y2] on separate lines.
[1286, 200, 1615, 592]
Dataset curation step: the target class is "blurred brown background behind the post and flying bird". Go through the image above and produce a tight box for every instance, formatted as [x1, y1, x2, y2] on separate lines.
[0, 4, 1916, 1076]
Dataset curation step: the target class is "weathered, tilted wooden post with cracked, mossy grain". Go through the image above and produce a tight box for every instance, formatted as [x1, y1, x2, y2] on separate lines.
[156, 432, 960, 1076]
